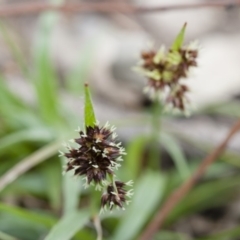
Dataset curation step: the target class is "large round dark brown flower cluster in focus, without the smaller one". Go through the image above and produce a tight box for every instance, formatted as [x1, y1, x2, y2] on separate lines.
[64, 124, 125, 186]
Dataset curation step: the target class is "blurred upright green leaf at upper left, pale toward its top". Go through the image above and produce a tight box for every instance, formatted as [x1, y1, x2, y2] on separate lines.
[33, 7, 60, 125]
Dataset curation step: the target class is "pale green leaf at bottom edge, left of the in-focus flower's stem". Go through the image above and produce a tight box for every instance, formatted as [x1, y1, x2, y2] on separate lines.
[45, 211, 90, 240]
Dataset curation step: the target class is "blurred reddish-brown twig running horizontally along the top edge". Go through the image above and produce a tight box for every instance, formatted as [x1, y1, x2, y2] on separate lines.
[0, 0, 240, 17]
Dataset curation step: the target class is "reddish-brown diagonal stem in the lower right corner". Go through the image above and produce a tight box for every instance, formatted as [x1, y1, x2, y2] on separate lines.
[139, 120, 240, 240]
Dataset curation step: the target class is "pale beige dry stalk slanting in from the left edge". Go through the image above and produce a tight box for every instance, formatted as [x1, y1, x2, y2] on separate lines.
[0, 141, 61, 191]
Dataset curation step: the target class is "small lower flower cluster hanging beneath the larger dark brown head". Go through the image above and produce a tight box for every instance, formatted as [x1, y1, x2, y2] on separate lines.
[101, 181, 133, 210]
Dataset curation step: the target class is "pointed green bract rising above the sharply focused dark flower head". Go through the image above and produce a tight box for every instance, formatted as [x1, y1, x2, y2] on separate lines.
[84, 83, 96, 127]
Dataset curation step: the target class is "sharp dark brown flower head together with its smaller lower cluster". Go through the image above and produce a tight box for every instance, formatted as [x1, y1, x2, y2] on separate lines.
[62, 123, 131, 209]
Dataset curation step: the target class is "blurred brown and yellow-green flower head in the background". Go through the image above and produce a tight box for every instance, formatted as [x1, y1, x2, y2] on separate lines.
[140, 43, 198, 111]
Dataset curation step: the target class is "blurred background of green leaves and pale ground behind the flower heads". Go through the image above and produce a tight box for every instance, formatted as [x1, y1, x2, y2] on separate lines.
[0, 0, 240, 240]
